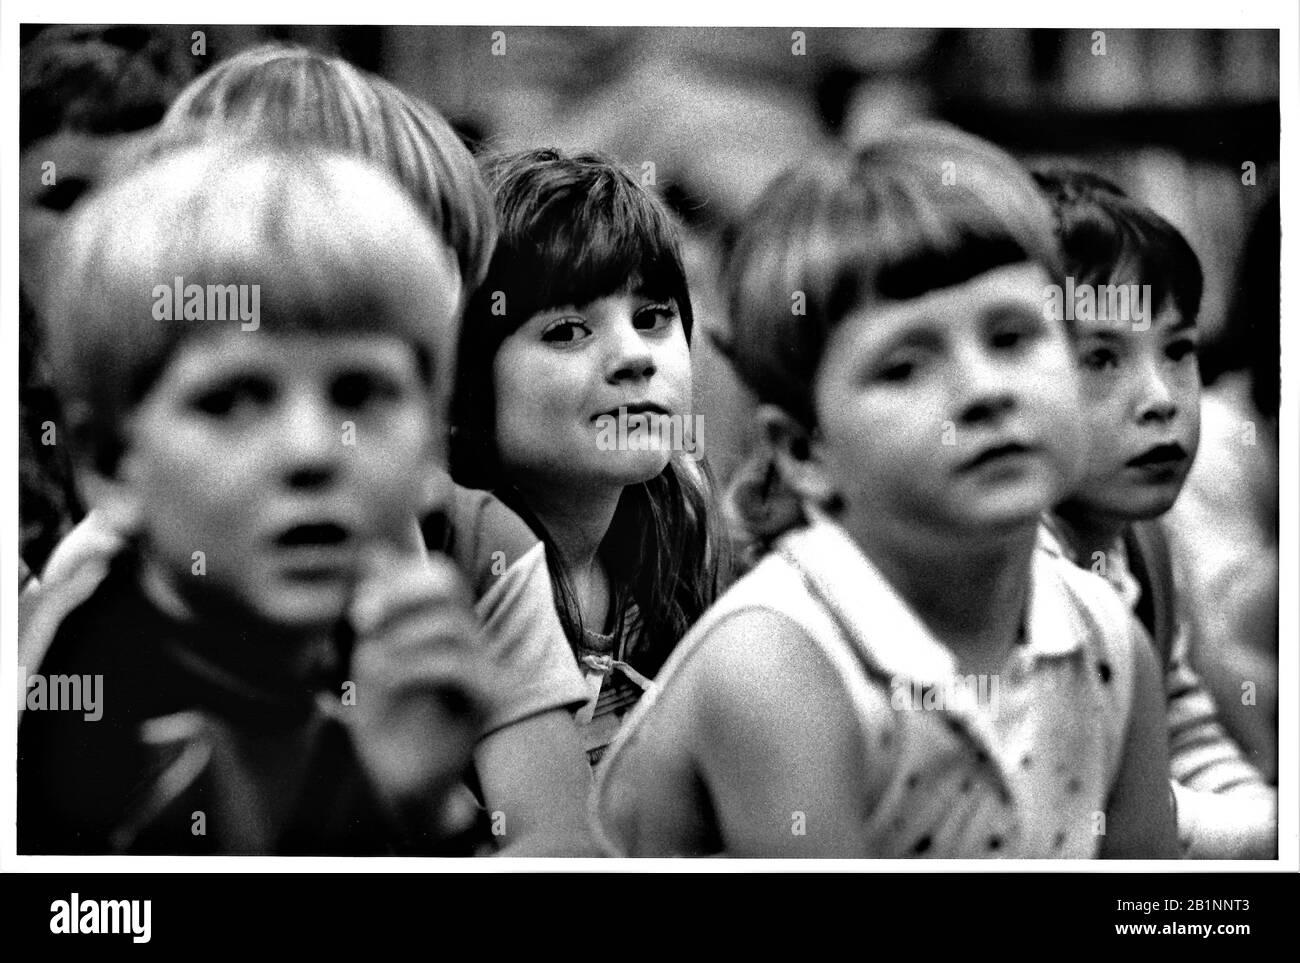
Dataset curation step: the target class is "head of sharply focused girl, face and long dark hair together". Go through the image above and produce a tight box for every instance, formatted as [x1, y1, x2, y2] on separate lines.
[451, 151, 716, 671]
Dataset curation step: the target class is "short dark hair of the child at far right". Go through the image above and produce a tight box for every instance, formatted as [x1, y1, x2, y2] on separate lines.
[1034, 168, 1204, 321]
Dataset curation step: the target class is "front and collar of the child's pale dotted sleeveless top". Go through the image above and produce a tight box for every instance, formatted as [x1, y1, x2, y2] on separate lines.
[779, 522, 1132, 859]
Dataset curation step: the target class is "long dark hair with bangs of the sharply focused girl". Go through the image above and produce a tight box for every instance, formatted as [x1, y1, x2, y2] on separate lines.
[451, 149, 724, 674]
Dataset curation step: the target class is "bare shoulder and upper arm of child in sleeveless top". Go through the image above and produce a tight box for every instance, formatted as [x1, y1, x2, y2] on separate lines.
[598, 607, 865, 855]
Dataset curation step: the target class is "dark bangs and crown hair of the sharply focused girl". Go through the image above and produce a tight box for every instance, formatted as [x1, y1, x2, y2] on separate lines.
[476, 149, 694, 340]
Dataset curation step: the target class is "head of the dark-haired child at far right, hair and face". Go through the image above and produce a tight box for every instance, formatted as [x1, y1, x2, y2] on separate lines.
[1035, 169, 1203, 521]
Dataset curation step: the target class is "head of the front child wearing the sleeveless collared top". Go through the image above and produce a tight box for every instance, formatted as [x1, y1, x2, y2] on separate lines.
[725, 126, 1080, 551]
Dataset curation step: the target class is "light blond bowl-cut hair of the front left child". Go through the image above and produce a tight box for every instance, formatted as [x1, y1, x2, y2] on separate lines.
[47, 142, 460, 473]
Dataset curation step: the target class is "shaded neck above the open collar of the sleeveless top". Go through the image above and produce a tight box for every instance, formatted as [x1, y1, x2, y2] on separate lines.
[855, 514, 1037, 672]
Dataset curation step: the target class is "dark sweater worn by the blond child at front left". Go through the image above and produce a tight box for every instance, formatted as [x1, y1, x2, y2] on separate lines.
[18, 552, 473, 855]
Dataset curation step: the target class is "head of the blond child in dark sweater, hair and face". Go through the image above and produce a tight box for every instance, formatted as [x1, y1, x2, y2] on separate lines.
[48, 142, 460, 632]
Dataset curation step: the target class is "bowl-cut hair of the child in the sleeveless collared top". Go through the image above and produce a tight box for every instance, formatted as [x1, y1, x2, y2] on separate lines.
[722, 125, 1062, 428]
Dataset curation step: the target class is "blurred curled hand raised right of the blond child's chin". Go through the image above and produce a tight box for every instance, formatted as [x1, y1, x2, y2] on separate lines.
[343, 548, 482, 832]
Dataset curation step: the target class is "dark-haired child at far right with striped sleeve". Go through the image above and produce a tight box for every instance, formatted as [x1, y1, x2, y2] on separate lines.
[1035, 170, 1277, 859]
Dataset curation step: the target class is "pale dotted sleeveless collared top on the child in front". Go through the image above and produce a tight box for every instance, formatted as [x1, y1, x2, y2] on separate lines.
[593, 519, 1135, 859]
